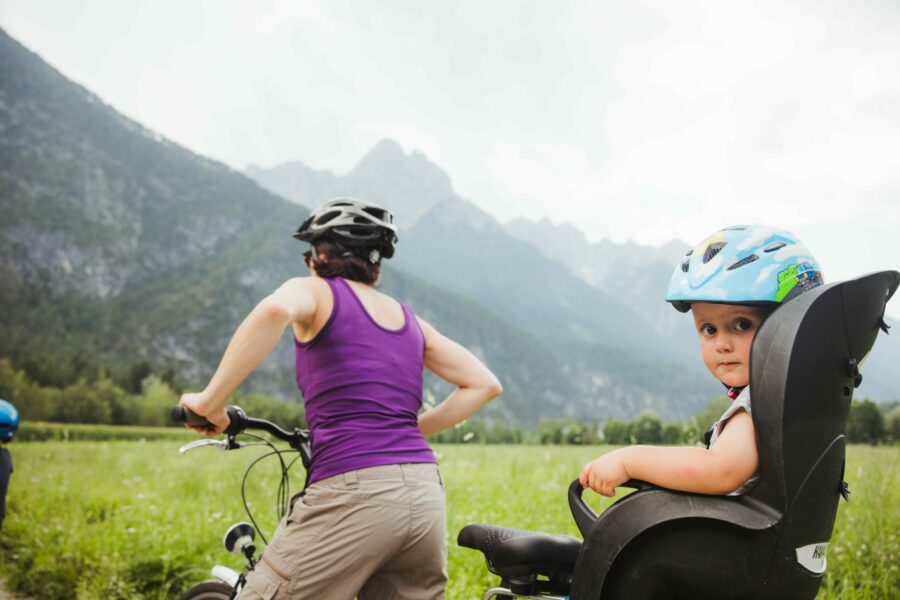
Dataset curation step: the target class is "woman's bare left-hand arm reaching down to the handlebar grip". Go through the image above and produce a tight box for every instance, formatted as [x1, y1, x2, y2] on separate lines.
[180, 277, 316, 435]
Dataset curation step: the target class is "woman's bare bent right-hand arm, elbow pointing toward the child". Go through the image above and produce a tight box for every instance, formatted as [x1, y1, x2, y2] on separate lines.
[419, 319, 503, 435]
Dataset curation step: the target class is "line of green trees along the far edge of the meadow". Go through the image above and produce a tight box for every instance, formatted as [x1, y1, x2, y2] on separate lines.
[0, 358, 900, 445]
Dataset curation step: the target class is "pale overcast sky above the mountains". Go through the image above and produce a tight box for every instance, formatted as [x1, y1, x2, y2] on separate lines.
[0, 0, 900, 317]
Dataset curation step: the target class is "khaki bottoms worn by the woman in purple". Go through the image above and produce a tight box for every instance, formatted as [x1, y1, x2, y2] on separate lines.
[240, 463, 447, 600]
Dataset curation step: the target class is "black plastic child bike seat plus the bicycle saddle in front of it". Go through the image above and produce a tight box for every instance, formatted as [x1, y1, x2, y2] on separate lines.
[460, 271, 900, 600]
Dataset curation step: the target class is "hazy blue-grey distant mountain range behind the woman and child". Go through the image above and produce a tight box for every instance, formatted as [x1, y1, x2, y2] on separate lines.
[248, 141, 900, 408]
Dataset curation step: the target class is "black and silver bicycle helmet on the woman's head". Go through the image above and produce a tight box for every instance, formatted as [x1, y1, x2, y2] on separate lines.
[294, 198, 397, 262]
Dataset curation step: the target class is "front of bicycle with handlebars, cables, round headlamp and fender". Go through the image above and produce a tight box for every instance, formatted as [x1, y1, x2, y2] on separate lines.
[171, 406, 311, 600]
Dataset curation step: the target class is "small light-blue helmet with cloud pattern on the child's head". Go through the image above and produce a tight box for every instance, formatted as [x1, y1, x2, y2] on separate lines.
[666, 225, 823, 312]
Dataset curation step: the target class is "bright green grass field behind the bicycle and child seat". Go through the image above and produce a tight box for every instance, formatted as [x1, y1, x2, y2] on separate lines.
[0, 440, 900, 600]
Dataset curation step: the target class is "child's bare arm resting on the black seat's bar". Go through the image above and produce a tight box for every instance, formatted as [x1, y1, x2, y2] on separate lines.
[579, 410, 759, 496]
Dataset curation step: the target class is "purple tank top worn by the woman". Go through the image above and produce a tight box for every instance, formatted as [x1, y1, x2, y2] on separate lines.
[294, 278, 437, 483]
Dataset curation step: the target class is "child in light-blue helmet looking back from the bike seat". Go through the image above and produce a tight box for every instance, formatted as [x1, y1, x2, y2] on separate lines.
[579, 225, 822, 496]
